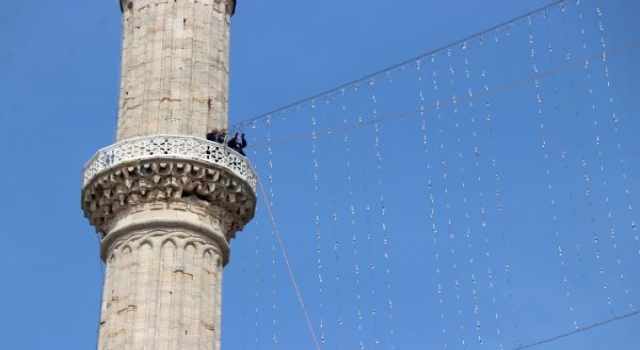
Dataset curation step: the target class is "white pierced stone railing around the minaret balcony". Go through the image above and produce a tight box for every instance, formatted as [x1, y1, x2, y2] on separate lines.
[82, 135, 257, 192]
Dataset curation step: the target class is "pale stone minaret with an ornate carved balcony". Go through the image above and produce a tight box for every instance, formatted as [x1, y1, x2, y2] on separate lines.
[82, 0, 256, 350]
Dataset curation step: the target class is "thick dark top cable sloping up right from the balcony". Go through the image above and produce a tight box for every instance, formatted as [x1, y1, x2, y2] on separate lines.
[230, 0, 566, 134]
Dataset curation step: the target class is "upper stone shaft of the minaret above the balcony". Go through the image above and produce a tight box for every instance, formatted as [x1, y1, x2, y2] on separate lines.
[117, 0, 235, 141]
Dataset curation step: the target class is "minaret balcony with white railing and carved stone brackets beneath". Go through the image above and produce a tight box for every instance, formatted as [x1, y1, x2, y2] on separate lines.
[82, 136, 256, 240]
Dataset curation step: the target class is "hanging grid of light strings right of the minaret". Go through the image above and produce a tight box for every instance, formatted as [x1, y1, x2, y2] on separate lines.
[225, 1, 640, 349]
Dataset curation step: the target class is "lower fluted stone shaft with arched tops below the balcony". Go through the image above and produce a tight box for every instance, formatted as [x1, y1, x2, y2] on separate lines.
[98, 229, 222, 350]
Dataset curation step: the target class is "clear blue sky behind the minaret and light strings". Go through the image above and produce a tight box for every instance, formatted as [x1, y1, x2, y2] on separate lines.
[0, 0, 640, 350]
